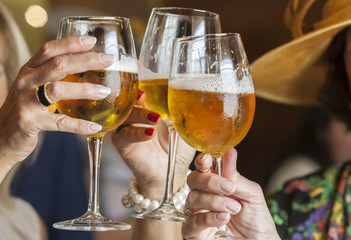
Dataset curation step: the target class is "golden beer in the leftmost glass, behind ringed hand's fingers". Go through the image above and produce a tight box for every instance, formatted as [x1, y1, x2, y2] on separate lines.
[57, 70, 138, 137]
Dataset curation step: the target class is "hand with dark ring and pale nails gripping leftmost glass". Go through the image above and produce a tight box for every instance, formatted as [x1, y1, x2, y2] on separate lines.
[0, 36, 112, 166]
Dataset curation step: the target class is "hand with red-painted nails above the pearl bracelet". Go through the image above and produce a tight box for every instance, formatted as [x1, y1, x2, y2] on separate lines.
[112, 91, 195, 200]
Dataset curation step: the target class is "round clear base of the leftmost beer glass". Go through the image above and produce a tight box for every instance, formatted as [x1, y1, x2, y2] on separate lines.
[53, 213, 131, 231]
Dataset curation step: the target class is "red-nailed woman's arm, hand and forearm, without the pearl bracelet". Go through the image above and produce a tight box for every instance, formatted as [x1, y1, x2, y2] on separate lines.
[112, 94, 195, 240]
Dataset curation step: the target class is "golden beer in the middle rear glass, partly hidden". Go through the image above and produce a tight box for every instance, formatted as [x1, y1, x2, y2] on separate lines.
[140, 79, 170, 120]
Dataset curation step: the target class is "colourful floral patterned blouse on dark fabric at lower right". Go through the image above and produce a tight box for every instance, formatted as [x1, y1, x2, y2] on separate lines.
[268, 162, 351, 240]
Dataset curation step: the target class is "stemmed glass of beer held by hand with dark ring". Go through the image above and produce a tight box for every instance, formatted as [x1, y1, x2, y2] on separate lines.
[54, 17, 138, 231]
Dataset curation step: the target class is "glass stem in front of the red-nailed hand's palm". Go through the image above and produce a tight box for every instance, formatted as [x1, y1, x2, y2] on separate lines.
[162, 126, 179, 205]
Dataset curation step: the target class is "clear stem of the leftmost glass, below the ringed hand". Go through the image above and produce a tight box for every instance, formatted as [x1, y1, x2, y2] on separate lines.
[87, 137, 102, 215]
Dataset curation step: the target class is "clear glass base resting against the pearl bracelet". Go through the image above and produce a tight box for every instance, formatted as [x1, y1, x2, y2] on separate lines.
[130, 203, 187, 222]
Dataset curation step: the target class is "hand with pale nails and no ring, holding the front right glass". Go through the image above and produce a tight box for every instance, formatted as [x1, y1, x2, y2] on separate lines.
[182, 149, 280, 240]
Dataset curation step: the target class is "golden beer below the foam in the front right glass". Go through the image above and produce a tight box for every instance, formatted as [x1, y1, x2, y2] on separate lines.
[168, 88, 255, 154]
